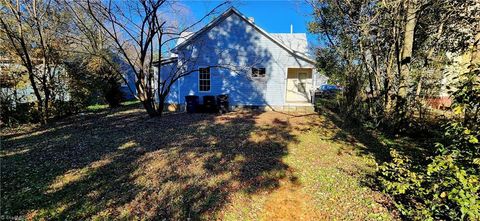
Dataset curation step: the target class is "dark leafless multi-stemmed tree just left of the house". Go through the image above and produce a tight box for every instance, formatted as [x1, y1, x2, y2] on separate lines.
[80, 0, 228, 117]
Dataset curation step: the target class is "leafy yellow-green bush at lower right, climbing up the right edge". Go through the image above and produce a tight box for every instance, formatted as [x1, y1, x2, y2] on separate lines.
[378, 68, 480, 220]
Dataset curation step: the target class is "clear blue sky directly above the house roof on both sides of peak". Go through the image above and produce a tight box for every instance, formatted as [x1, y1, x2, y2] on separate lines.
[176, 0, 317, 44]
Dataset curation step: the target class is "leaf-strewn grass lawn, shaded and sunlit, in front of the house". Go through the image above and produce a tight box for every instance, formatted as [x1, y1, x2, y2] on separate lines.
[0, 104, 420, 220]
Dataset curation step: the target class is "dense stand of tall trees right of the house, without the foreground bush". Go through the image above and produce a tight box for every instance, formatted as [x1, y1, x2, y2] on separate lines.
[309, 0, 480, 130]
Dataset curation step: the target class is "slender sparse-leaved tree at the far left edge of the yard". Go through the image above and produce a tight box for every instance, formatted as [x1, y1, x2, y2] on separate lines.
[0, 0, 72, 123]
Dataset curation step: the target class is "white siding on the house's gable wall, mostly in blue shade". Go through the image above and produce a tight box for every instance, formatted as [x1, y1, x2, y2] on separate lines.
[164, 13, 326, 106]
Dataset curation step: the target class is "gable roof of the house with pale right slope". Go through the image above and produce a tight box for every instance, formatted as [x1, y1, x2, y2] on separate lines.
[171, 7, 315, 64]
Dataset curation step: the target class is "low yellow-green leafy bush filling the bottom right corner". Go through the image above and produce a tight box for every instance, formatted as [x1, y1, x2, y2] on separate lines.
[379, 128, 480, 220]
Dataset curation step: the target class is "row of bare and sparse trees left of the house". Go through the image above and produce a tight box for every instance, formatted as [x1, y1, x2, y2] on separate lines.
[0, 0, 228, 123]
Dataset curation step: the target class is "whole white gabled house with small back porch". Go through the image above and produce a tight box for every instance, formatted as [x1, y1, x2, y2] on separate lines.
[157, 8, 327, 110]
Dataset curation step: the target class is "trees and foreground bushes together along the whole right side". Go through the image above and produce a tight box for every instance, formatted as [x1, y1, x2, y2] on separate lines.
[309, 0, 480, 220]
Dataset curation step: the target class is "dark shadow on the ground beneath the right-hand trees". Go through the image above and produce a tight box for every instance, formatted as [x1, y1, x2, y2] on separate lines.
[319, 107, 437, 217]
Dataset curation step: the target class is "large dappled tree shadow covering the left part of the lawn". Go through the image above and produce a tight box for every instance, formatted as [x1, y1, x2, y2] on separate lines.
[1, 106, 296, 219]
